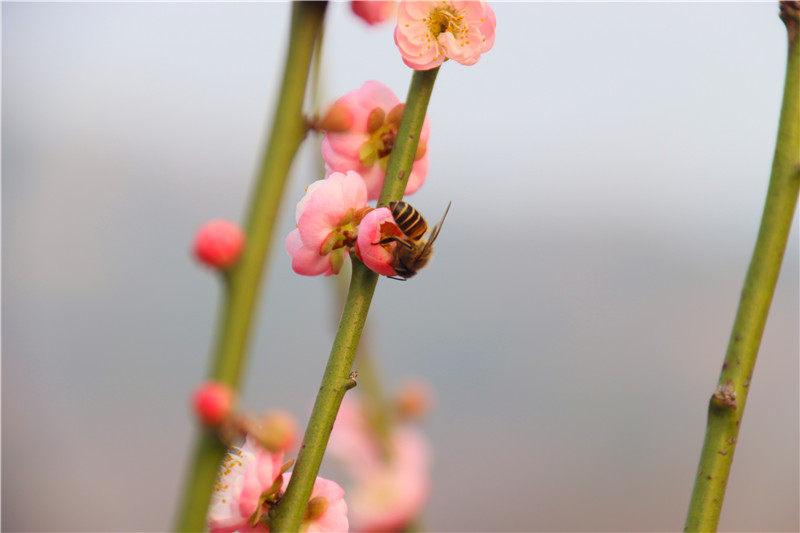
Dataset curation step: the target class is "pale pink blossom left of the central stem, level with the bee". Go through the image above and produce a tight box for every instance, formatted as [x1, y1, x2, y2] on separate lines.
[286, 171, 369, 276]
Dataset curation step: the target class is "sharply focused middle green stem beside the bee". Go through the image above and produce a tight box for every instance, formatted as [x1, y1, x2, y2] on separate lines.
[270, 68, 439, 533]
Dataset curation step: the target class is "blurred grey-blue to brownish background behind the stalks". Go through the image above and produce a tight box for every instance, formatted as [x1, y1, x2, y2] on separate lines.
[2, 2, 800, 532]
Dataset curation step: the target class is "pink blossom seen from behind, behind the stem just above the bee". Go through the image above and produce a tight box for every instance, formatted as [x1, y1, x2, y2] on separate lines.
[322, 81, 430, 200]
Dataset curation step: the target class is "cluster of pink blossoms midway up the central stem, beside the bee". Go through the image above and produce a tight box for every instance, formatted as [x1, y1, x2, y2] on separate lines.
[285, 81, 430, 276]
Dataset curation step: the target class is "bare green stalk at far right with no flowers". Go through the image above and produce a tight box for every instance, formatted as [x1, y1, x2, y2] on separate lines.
[684, 2, 800, 531]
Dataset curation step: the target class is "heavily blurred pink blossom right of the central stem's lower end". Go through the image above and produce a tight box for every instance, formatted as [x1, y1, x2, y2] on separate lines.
[328, 393, 430, 532]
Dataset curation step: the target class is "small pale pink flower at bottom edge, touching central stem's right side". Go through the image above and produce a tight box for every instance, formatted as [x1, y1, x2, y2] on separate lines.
[283, 472, 349, 533]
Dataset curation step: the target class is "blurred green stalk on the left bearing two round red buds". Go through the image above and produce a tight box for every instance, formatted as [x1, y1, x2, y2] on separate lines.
[176, 2, 327, 531]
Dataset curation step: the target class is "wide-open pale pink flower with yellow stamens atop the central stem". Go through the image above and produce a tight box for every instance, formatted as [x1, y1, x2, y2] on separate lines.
[394, 0, 497, 70]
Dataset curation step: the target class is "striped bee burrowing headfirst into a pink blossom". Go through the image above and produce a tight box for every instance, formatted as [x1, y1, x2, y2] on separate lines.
[375, 201, 450, 281]
